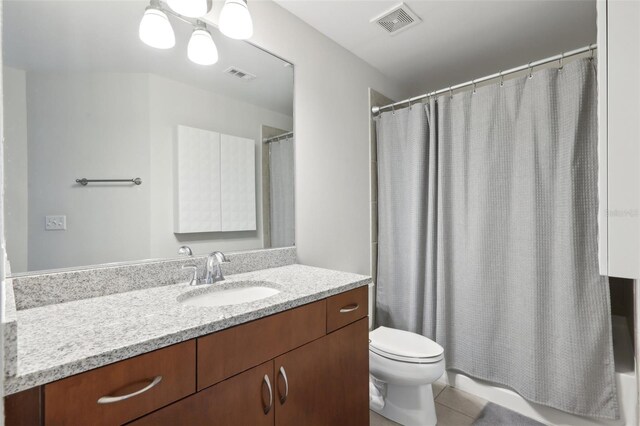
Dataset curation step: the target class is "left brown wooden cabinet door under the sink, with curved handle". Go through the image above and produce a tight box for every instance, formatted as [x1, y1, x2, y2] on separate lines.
[130, 361, 275, 426]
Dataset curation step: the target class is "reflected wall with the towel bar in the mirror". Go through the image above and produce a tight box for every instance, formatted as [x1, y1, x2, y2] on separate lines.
[25, 72, 150, 272]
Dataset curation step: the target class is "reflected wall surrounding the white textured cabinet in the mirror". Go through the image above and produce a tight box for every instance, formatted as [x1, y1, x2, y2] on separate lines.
[149, 76, 293, 258]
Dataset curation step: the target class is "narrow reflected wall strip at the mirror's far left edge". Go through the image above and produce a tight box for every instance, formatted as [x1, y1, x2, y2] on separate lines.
[3, 68, 29, 271]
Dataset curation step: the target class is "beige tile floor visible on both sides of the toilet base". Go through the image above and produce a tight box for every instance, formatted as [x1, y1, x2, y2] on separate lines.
[369, 382, 487, 426]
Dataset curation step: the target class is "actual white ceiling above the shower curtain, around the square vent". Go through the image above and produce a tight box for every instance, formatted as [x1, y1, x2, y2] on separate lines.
[275, 0, 596, 96]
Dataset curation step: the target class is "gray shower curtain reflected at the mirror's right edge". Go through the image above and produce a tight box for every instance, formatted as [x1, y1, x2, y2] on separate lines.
[269, 136, 295, 248]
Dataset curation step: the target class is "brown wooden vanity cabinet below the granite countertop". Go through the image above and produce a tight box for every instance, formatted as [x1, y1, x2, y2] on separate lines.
[5, 287, 369, 426]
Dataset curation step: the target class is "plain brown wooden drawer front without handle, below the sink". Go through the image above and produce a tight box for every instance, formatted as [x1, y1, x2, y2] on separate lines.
[198, 300, 326, 390]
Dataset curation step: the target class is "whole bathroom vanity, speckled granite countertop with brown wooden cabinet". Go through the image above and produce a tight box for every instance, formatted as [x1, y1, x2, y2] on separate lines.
[5, 255, 370, 425]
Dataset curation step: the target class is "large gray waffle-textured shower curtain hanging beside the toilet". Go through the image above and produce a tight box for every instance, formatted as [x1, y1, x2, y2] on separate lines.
[376, 59, 618, 418]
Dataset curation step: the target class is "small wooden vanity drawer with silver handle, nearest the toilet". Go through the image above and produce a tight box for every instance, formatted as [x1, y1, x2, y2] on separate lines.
[327, 285, 369, 333]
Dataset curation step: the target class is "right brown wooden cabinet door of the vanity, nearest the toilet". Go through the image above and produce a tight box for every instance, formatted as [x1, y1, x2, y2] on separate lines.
[275, 318, 369, 426]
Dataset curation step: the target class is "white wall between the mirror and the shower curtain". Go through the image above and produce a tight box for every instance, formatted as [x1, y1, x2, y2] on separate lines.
[232, 1, 409, 274]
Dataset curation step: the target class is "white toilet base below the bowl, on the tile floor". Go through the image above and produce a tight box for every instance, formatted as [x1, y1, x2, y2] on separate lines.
[371, 383, 437, 426]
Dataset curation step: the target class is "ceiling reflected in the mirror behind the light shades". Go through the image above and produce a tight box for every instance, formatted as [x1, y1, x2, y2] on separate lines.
[2, 0, 293, 115]
